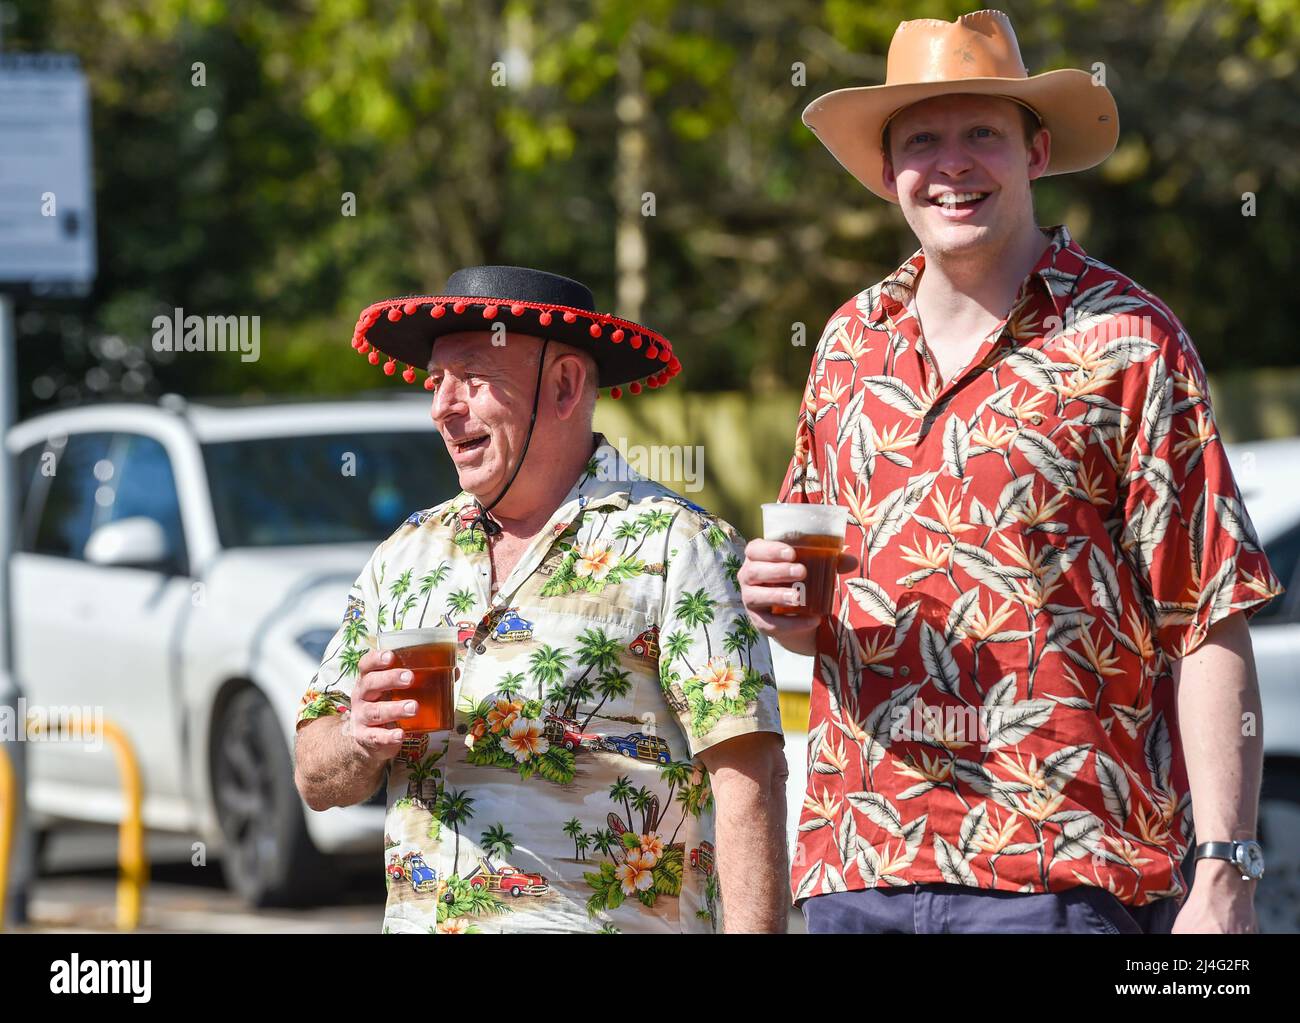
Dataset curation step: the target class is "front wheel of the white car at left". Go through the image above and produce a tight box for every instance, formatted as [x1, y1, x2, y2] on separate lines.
[212, 689, 325, 906]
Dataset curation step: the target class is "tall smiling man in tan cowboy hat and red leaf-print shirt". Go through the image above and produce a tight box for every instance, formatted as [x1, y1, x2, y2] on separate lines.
[741, 10, 1279, 932]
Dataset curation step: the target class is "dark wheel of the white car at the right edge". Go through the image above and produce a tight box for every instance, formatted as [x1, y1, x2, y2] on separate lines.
[1255, 763, 1300, 935]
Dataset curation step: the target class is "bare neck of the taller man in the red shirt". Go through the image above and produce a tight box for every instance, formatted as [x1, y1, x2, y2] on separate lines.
[917, 224, 1052, 322]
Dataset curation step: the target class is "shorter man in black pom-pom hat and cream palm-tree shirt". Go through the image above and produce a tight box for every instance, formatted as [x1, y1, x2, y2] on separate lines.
[296, 266, 789, 933]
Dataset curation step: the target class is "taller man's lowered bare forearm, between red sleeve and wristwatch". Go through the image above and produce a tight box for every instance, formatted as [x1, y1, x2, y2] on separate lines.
[1174, 614, 1264, 842]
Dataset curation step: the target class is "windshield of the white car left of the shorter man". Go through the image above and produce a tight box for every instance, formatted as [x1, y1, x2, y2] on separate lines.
[203, 430, 460, 547]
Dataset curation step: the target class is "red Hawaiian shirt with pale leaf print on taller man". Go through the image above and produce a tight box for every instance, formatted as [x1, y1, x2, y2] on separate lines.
[783, 226, 1282, 905]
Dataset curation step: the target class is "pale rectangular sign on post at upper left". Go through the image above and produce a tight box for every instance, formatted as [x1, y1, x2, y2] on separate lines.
[0, 53, 95, 294]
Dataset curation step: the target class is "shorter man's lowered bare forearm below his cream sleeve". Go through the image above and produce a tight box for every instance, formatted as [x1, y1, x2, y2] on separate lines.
[706, 732, 790, 933]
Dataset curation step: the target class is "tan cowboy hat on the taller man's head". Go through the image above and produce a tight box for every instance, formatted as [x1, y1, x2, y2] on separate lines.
[803, 10, 1119, 203]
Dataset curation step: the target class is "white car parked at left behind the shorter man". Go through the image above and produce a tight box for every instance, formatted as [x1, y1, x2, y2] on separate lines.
[8, 395, 459, 905]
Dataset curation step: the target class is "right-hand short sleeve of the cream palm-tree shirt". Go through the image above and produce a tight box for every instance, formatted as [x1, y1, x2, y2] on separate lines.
[659, 520, 781, 757]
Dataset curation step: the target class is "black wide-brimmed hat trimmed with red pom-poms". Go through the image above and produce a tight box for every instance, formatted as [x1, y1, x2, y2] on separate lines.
[352, 266, 681, 398]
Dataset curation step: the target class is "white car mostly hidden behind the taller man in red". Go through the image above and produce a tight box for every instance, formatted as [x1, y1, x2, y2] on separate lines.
[772, 439, 1300, 933]
